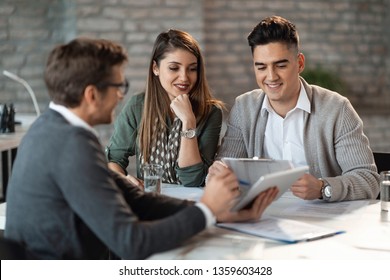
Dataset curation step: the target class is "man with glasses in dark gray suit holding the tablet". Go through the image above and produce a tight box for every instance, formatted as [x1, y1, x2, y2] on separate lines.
[5, 38, 277, 259]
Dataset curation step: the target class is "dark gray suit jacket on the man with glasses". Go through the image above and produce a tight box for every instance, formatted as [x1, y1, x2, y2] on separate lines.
[5, 109, 205, 259]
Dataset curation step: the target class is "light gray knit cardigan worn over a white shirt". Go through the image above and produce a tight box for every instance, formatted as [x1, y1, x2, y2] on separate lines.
[217, 79, 379, 201]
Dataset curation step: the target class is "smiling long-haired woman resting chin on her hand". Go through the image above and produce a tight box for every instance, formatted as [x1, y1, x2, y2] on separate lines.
[106, 29, 223, 187]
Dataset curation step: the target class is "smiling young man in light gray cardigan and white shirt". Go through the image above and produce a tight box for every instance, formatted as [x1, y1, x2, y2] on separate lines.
[218, 16, 379, 201]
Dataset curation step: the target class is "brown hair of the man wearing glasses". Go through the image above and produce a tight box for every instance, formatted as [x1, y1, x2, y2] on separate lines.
[45, 38, 127, 108]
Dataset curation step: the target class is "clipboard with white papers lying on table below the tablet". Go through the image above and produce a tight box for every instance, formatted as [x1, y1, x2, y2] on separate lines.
[218, 217, 344, 243]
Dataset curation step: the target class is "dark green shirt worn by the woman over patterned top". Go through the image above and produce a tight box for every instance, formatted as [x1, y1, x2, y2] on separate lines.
[106, 93, 222, 187]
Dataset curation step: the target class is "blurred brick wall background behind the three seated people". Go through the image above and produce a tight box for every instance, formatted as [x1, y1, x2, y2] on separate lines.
[0, 0, 390, 152]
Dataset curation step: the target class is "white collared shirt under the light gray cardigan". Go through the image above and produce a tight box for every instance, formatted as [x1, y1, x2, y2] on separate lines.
[261, 83, 311, 167]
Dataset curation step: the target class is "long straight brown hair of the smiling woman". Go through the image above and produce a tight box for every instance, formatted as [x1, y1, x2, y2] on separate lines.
[139, 29, 224, 162]
